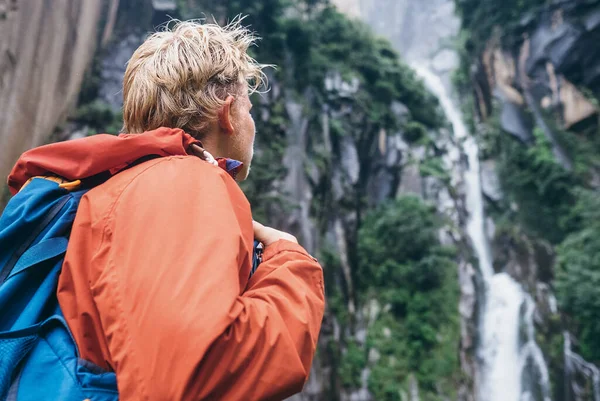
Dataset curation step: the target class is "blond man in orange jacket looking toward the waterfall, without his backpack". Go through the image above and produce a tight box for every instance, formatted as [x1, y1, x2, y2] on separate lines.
[9, 22, 324, 401]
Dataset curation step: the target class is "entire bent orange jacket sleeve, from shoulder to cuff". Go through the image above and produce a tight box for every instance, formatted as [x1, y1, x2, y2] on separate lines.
[92, 158, 324, 401]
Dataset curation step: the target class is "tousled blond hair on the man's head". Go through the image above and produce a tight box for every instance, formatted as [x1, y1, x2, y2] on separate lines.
[123, 18, 266, 137]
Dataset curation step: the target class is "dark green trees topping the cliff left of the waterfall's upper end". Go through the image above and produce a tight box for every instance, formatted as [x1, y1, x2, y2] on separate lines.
[292, 7, 443, 128]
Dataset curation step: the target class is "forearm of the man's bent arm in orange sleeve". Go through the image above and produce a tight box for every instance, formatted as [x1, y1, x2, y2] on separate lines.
[191, 240, 324, 400]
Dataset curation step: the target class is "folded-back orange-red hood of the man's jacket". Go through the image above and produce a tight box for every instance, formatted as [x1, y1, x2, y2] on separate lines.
[8, 128, 199, 195]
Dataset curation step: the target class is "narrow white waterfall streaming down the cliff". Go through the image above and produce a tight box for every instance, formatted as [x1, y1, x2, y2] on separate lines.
[412, 63, 550, 401]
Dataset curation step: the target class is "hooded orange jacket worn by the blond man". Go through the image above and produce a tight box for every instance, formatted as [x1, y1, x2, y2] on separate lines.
[9, 128, 324, 401]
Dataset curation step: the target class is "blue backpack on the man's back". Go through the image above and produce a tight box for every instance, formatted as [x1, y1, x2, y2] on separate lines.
[0, 177, 118, 401]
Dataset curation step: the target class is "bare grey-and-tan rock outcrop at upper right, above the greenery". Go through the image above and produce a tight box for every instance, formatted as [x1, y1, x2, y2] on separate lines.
[472, 1, 600, 138]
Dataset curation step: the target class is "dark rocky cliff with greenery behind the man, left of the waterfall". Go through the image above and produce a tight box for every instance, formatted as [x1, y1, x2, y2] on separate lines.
[63, 0, 471, 400]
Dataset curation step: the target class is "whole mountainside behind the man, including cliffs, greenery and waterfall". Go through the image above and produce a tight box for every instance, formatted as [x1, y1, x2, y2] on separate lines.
[0, 0, 600, 401]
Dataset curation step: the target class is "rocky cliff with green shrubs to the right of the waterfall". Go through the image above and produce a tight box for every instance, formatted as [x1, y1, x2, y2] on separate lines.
[455, 0, 600, 400]
